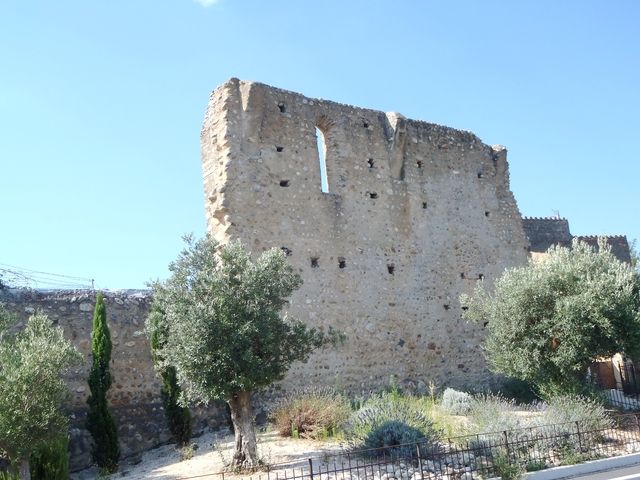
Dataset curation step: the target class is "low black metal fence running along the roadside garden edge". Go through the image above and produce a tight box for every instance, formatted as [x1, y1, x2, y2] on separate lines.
[174, 414, 640, 480]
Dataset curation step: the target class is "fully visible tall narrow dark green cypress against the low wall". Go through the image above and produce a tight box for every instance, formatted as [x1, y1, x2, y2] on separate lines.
[86, 293, 120, 472]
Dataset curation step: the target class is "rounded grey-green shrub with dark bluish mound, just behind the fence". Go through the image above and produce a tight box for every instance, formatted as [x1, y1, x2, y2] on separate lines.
[345, 393, 440, 456]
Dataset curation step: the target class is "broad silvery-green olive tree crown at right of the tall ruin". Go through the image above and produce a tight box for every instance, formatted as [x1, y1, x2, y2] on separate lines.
[461, 241, 640, 396]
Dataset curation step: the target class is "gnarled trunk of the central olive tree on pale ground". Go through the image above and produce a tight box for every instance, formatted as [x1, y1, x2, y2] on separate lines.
[227, 392, 259, 469]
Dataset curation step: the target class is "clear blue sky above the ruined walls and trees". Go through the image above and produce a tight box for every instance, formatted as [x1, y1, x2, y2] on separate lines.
[0, 0, 640, 289]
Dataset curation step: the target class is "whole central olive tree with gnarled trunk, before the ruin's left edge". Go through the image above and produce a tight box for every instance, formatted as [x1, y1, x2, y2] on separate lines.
[147, 237, 340, 468]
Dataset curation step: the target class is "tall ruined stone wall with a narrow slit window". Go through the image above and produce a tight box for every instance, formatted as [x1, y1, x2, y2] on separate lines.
[201, 79, 528, 390]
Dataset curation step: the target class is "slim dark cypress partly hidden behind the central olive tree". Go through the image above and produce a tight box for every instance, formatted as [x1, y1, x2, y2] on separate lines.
[146, 284, 191, 446]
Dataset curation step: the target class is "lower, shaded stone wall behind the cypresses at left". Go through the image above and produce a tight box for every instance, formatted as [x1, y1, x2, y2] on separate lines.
[0, 290, 225, 470]
